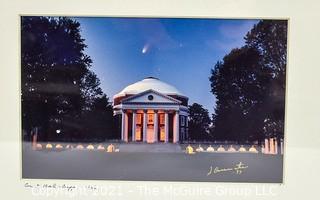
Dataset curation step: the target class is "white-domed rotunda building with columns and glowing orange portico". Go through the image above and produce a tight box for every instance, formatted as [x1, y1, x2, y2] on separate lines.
[113, 77, 188, 143]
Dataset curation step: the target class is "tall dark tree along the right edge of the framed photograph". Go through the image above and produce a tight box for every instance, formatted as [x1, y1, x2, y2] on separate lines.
[245, 20, 287, 137]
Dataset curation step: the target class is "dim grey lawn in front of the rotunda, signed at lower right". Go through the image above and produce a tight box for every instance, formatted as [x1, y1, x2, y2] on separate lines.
[22, 142, 283, 183]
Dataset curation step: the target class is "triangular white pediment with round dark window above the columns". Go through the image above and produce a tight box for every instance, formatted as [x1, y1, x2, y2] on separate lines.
[122, 90, 181, 104]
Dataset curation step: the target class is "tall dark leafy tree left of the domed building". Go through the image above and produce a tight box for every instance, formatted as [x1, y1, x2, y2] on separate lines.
[21, 17, 116, 141]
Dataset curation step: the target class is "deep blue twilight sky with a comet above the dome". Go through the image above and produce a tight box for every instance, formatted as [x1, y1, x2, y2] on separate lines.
[75, 17, 258, 113]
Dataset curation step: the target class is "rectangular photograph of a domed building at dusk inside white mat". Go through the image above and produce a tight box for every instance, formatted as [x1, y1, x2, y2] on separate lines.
[20, 15, 288, 183]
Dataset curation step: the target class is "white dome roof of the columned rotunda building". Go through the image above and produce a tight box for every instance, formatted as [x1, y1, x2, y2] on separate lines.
[114, 77, 185, 98]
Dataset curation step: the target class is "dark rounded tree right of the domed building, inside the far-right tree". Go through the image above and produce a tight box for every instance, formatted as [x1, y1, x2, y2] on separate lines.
[210, 47, 269, 141]
